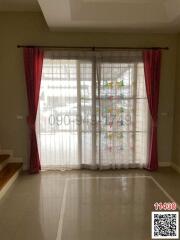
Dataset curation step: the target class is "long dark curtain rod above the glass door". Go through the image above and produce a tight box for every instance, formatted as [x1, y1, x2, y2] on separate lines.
[17, 45, 169, 51]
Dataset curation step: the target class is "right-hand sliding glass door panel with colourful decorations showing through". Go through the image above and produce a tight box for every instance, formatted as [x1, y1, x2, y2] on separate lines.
[97, 63, 148, 167]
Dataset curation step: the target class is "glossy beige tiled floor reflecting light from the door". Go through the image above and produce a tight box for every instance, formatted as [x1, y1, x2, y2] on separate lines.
[0, 168, 180, 240]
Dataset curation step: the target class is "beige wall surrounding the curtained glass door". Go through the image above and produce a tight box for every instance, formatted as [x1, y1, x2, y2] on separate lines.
[0, 13, 177, 168]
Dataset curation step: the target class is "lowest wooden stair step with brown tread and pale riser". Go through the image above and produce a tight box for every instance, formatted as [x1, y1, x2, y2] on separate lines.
[0, 163, 22, 198]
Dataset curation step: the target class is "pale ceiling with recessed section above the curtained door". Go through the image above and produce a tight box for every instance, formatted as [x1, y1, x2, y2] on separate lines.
[0, 0, 180, 32]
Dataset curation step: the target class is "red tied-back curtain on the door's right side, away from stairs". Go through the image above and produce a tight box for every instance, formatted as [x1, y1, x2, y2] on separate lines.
[143, 49, 161, 171]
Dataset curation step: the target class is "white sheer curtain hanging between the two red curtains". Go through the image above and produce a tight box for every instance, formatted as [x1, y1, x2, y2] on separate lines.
[36, 51, 149, 169]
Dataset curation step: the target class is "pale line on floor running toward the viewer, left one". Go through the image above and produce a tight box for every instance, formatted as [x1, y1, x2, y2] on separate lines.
[56, 179, 69, 240]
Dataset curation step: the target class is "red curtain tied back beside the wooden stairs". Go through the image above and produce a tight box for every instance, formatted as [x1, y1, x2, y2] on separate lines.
[23, 48, 44, 173]
